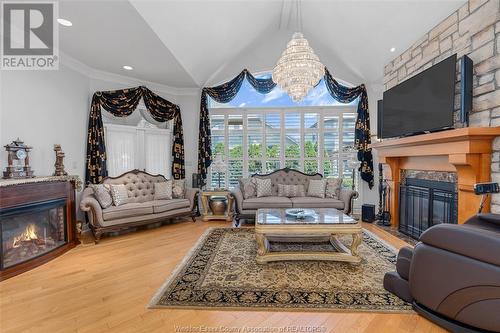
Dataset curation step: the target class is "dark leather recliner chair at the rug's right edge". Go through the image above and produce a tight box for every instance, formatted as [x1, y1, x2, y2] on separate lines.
[384, 214, 500, 332]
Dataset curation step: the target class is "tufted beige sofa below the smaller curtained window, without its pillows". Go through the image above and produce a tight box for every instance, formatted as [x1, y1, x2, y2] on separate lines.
[80, 170, 198, 243]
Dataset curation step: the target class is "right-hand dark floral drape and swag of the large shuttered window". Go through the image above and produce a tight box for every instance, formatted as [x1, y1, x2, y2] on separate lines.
[325, 68, 373, 188]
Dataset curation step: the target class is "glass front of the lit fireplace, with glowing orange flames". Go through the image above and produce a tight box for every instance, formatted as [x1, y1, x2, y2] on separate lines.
[0, 200, 67, 269]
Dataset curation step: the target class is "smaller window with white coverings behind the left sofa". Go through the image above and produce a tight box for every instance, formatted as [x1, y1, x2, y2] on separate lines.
[104, 121, 172, 178]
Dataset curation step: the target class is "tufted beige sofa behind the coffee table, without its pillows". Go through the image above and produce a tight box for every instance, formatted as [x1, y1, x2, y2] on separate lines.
[232, 168, 358, 224]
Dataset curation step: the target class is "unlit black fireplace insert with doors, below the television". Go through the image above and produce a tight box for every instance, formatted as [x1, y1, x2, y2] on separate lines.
[399, 178, 458, 239]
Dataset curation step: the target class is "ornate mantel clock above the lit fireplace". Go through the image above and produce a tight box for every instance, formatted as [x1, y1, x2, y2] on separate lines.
[3, 138, 34, 179]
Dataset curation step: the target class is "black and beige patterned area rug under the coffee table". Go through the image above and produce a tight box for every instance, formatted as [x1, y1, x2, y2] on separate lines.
[149, 228, 411, 312]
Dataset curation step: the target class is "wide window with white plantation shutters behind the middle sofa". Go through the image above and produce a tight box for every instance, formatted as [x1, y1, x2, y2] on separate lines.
[209, 105, 356, 188]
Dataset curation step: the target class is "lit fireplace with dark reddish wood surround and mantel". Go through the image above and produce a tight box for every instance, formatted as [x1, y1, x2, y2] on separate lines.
[0, 176, 78, 281]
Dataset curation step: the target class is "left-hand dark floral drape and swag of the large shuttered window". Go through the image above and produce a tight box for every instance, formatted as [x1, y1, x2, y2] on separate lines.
[198, 69, 276, 181]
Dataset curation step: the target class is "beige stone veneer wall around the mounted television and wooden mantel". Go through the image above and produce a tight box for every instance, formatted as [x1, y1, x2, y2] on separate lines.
[384, 0, 500, 213]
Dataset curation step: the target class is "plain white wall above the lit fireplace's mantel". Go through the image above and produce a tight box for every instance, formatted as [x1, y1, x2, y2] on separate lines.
[0, 65, 89, 179]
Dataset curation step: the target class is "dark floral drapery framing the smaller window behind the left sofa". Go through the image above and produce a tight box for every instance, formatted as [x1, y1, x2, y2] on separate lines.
[85, 86, 185, 184]
